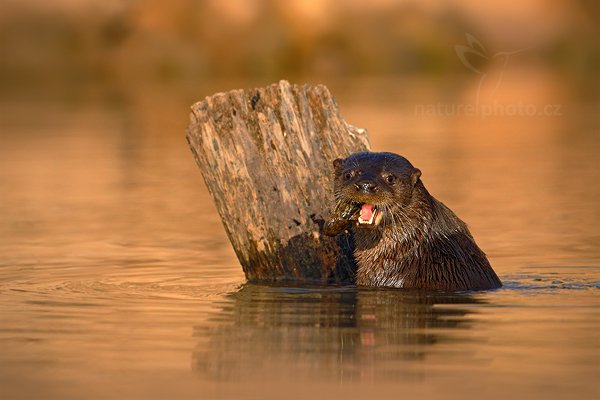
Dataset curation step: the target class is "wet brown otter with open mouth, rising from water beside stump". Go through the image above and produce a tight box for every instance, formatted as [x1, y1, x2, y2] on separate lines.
[323, 152, 502, 291]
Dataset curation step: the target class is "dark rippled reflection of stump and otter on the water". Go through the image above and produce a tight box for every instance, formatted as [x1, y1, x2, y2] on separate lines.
[193, 284, 482, 381]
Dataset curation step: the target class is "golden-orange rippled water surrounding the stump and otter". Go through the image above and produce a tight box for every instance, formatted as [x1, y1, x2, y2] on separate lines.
[0, 80, 600, 399]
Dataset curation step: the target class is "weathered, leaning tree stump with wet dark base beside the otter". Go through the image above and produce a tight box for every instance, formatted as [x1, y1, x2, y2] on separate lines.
[187, 81, 369, 284]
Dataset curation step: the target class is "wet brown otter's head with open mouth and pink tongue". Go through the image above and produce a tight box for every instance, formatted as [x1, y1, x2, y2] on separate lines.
[333, 152, 421, 227]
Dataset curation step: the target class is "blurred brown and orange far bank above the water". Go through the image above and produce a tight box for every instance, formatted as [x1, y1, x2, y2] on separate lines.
[0, 0, 600, 90]
